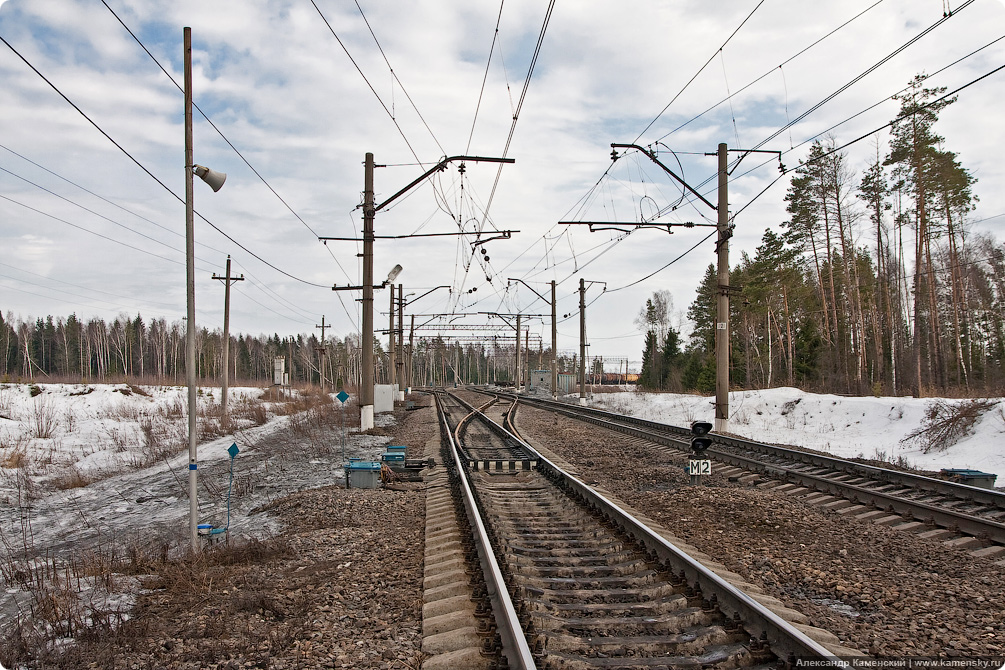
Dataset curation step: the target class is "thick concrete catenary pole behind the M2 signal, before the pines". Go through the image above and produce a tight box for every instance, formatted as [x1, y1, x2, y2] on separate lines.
[716, 143, 730, 433]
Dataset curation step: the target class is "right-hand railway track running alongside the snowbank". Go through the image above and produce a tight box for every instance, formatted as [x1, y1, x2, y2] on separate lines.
[486, 394, 1005, 556]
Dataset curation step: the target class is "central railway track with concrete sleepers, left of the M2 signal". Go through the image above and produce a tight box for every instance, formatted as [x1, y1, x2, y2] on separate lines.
[437, 393, 848, 670]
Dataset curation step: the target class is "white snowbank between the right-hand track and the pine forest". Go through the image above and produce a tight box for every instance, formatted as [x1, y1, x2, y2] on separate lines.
[590, 388, 1005, 487]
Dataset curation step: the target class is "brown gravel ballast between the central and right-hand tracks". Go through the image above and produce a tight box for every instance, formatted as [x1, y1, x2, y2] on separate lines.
[518, 397, 1005, 657]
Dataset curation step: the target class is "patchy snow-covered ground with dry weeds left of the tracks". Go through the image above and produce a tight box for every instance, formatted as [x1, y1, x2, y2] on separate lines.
[0, 384, 394, 625]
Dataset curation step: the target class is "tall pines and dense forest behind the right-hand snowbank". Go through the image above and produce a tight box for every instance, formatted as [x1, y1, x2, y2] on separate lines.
[636, 75, 1005, 396]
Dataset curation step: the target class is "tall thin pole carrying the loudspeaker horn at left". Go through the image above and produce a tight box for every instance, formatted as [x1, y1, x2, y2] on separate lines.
[183, 27, 199, 553]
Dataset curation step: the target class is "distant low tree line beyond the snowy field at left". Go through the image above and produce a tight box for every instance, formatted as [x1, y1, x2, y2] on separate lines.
[0, 312, 578, 390]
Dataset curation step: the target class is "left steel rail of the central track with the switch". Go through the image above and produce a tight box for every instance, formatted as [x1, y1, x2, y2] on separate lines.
[434, 394, 538, 670]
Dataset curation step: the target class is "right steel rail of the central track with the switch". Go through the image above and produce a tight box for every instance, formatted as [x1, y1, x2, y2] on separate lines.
[450, 387, 847, 668]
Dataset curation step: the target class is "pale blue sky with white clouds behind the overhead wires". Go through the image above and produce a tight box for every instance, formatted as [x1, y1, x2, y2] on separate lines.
[0, 0, 1005, 365]
